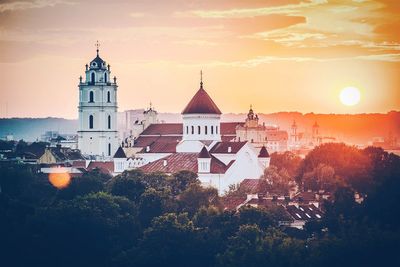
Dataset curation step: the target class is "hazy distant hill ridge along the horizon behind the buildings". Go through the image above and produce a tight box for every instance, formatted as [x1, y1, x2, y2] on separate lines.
[0, 111, 400, 143]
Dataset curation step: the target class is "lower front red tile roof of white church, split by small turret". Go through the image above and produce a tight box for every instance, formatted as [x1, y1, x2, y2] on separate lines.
[140, 153, 234, 174]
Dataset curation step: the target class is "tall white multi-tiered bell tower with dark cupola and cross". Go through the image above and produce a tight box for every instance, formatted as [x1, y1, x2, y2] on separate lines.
[78, 42, 119, 159]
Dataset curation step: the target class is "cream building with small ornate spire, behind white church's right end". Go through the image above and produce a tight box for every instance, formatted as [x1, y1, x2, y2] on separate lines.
[236, 106, 288, 152]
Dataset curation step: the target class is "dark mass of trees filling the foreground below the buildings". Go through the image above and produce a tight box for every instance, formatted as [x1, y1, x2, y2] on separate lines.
[0, 144, 400, 267]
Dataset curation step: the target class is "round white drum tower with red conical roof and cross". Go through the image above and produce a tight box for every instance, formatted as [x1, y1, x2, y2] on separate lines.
[182, 72, 222, 141]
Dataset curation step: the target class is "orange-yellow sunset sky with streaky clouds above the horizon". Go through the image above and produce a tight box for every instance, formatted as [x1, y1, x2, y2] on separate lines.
[0, 0, 400, 119]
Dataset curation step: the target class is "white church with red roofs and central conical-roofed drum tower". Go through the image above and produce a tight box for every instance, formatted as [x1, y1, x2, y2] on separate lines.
[122, 76, 270, 194]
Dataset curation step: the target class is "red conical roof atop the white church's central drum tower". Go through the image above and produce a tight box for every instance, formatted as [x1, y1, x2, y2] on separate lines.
[182, 86, 222, 114]
